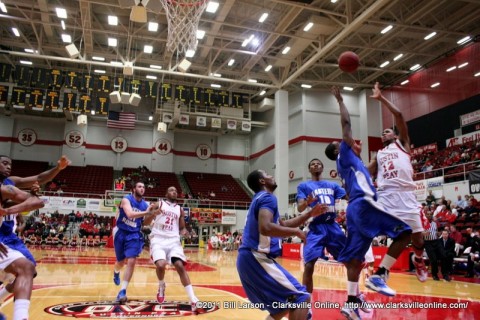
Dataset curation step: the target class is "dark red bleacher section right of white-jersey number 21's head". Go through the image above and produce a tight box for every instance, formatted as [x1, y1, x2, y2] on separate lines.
[183, 172, 251, 202]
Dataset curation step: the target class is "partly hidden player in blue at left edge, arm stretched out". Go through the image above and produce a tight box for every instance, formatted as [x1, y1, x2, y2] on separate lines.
[0, 155, 71, 301]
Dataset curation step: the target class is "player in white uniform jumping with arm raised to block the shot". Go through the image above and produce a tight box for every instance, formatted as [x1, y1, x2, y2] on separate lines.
[366, 82, 428, 290]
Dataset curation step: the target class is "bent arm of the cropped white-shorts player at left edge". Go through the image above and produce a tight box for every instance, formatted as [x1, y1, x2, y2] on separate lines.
[0, 185, 44, 215]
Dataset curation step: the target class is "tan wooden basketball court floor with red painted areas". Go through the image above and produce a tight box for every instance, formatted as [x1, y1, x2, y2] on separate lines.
[0, 247, 480, 320]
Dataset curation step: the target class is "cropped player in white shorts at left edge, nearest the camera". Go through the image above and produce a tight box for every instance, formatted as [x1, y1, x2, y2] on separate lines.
[0, 178, 44, 320]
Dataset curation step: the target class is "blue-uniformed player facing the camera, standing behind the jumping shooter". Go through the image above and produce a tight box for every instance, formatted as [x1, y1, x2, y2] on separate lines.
[297, 158, 346, 293]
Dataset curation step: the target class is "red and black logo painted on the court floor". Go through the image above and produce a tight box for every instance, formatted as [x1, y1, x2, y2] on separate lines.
[44, 300, 218, 319]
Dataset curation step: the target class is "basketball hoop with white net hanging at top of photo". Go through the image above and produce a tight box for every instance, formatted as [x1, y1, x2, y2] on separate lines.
[160, 0, 207, 53]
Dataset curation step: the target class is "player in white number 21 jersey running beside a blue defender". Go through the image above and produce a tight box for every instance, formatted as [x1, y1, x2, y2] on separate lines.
[144, 187, 199, 312]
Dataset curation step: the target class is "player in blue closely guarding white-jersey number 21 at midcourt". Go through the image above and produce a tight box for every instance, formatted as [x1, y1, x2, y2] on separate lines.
[113, 181, 159, 303]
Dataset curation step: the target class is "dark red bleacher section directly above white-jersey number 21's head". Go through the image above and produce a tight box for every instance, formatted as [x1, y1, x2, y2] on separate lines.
[122, 168, 182, 198]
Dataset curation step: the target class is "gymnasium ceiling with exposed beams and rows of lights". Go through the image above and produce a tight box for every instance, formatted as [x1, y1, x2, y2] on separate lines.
[0, 0, 480, 102]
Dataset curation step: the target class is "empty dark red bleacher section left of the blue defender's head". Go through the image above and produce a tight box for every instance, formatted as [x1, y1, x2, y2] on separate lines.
[56, 166, 113, 195]
